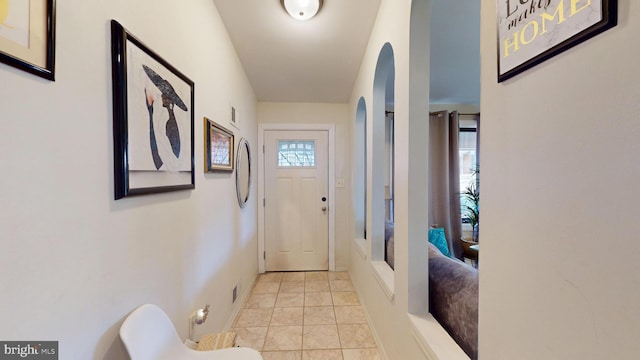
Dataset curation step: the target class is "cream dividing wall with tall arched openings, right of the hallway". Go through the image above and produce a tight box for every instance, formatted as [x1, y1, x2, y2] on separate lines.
[350, 0, 430, 360]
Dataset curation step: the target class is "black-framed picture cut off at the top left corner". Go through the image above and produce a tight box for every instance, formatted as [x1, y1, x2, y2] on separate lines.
[0, 0, 56, 81]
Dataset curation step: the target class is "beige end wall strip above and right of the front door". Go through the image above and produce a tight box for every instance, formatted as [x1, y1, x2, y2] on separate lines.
[257, 102, 352, 270]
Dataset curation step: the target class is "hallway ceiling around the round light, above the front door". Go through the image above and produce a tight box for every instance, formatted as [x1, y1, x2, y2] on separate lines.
[214, 0, 380, 103]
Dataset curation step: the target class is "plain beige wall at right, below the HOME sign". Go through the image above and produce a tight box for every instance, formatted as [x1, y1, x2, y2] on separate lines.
[480, 0, 640, 360]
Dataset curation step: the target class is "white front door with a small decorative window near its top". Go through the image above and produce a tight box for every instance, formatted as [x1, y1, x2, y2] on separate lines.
[264, 130, 329, 271]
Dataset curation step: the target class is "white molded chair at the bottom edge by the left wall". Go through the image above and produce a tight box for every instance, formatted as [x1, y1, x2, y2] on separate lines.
[120, 304, 262, 360]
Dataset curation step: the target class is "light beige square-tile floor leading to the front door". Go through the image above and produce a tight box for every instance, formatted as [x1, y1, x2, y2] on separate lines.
[231, 271, 380, 360]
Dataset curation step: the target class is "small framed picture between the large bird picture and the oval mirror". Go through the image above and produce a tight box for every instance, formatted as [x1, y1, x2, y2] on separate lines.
[204, 117, 234, 172]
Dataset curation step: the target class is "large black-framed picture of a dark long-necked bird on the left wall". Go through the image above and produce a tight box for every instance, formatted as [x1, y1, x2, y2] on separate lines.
[111, 20, 195, 200]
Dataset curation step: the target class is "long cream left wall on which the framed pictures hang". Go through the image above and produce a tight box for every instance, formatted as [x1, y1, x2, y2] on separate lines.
[0, 0, 257, 359]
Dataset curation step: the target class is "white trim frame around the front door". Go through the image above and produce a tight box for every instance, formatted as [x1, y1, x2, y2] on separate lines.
[258, 124, 336, 274]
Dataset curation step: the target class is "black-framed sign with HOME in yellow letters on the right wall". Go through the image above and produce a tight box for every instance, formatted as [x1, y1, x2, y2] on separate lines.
[497, 0, 618, 82]
